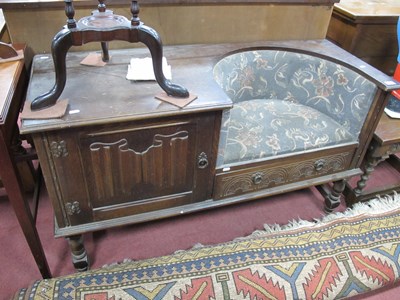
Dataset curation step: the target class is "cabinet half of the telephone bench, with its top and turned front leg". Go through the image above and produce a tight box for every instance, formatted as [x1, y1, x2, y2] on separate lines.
[22, 46, 231, 269]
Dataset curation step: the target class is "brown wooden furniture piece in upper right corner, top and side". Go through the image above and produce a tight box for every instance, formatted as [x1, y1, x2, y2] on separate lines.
[327, 0, 400, 75]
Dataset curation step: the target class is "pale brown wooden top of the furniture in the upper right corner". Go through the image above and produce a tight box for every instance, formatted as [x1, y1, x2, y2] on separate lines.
[334, 0, 400, 23]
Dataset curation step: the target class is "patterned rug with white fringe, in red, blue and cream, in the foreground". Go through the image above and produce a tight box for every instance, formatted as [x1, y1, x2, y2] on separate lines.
[15, 195, 400, 300]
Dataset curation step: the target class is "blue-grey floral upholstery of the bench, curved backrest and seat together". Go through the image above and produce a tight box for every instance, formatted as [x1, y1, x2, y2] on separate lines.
[214, 50, 377, 167]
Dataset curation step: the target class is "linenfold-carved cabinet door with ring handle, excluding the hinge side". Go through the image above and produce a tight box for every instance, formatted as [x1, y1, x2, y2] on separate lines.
[79, 116, 219, 221]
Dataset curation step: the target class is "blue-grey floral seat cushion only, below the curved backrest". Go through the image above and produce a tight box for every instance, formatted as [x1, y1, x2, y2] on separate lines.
[217, 99, 355, 167]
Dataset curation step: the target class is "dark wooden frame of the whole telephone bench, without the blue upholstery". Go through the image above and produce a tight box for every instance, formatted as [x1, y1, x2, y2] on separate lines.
[21, 40, 399, 269]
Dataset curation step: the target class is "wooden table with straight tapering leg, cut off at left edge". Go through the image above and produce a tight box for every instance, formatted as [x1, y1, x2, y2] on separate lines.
[0, 45, 51, 278]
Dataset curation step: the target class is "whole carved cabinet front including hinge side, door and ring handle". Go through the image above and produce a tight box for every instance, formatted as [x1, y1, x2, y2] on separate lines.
[35, 112, 220, 230]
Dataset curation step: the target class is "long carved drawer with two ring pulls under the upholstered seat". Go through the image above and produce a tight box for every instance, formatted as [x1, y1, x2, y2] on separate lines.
[214, 151, 353, 200]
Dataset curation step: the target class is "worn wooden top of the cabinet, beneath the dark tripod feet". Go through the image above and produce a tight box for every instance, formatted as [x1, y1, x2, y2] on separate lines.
[21, 45, 232, 133]
